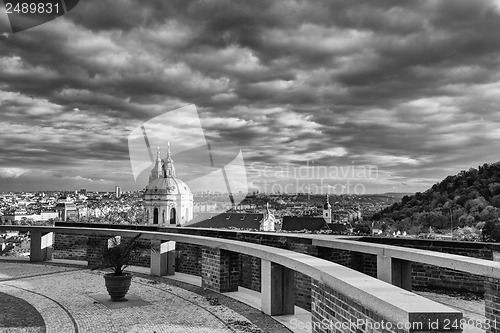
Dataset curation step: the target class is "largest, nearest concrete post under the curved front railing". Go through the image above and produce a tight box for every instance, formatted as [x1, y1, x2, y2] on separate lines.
[261, 259, 295, 316]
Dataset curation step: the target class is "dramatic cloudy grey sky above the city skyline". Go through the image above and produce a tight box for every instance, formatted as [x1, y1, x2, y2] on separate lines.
[0, 0, 500, 193]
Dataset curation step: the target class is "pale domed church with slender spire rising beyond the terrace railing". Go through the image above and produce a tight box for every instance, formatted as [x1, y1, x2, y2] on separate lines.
[143, 145, 193, 227]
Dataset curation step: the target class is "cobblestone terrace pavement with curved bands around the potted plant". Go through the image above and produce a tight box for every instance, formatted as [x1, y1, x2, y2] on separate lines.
[0, 260, 286, 333]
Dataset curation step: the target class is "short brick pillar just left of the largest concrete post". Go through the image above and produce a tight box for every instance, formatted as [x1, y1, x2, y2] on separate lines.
[201, 247, 240, 292]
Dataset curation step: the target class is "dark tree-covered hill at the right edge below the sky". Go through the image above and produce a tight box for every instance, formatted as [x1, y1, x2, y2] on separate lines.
[372, 162, 500, 236]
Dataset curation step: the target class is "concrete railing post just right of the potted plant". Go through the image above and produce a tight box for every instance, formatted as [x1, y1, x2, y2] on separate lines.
[150, 240, 175, 276]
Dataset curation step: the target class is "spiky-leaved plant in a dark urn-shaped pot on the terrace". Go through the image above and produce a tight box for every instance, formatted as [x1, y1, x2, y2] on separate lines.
[92, 234, 141, 302]
